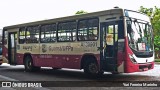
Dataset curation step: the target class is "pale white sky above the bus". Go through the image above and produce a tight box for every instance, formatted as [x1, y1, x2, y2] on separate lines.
[0, 0, 160, 29]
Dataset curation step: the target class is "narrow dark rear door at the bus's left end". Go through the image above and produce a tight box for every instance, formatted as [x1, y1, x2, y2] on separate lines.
[8, 32, 17, 65]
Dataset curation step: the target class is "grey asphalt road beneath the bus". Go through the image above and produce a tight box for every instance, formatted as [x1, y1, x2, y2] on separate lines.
[0, 64, 160, 90]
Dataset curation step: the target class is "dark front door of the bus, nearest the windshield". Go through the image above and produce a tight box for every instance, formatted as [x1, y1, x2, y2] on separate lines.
[100, 21, 118, 72]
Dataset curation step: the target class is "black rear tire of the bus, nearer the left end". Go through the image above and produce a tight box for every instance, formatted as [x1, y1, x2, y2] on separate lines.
[24, 56, 40, 72]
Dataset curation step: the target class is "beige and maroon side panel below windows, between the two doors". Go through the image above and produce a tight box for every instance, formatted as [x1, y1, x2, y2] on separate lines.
[17, 41, 99, 69]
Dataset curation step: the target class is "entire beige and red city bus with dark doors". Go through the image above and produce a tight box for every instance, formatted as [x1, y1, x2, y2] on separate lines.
[2, 8, 154, 75]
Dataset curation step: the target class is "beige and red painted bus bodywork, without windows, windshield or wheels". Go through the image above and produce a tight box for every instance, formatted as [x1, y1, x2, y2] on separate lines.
[0, 9, 154, 73]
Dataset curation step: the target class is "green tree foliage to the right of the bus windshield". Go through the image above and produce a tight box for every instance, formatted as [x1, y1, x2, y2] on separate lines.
[139, 6, 160, 50]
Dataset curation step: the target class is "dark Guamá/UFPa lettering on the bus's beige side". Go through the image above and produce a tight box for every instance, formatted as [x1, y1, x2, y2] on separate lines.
[49, 46, 73, 51]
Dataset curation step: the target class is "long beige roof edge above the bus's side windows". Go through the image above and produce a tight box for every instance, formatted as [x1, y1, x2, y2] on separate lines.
[3, 8, 123, 29]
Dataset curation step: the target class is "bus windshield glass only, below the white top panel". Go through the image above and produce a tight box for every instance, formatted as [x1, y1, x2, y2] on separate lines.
[127, 17, 153, 51]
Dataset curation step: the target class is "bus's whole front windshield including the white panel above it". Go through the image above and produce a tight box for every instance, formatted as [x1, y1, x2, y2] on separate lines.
[125, 10, 153, 52]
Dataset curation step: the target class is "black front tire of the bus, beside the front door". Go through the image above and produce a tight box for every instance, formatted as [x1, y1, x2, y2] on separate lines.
[84, 60, 104, 76]
